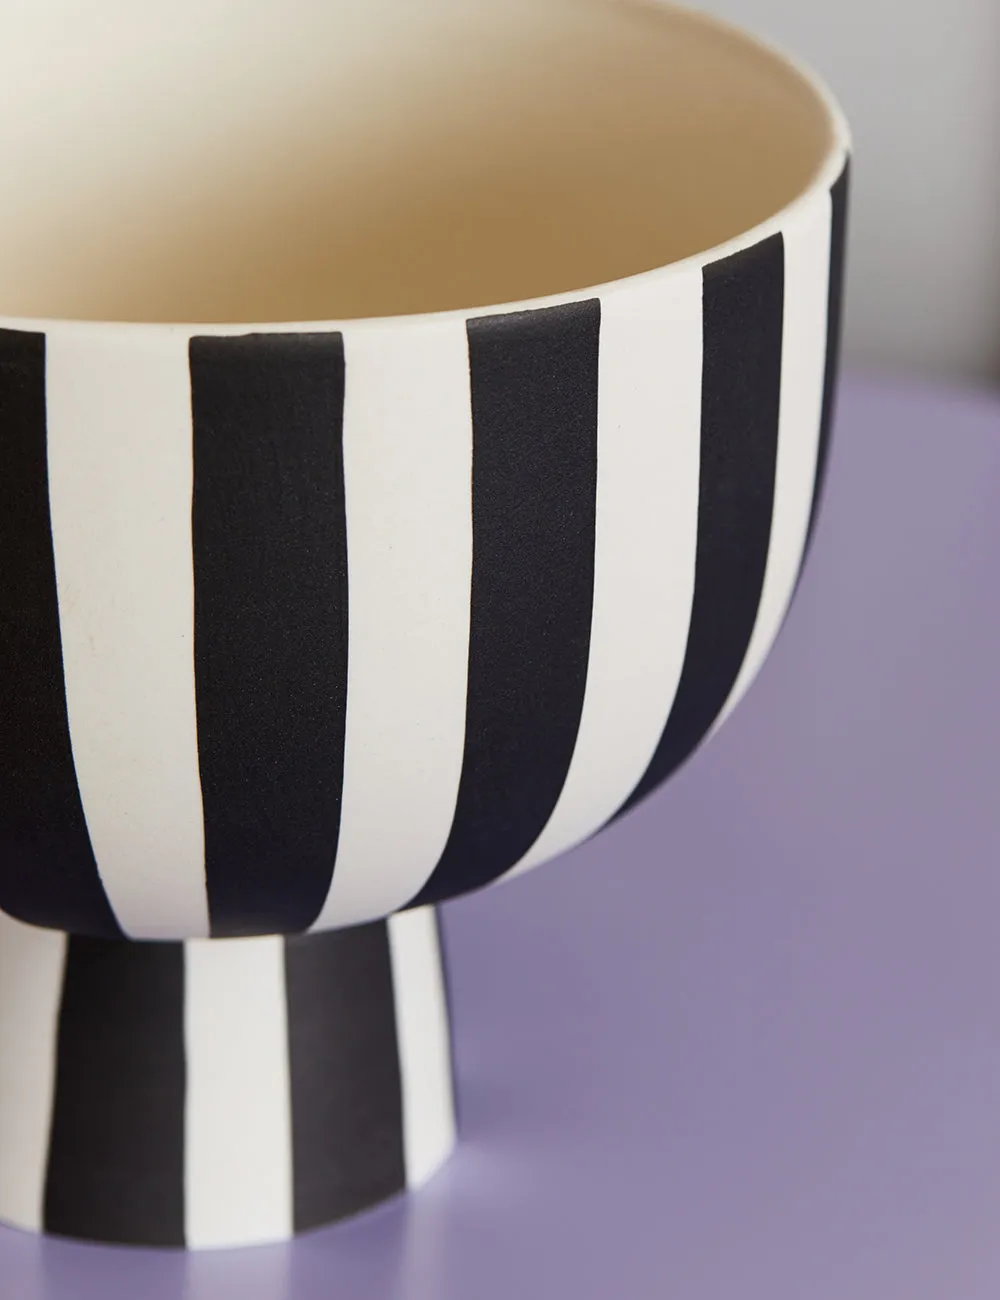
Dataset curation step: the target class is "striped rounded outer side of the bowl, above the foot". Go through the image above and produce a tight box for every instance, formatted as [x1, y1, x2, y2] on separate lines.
[0, 162, 847, 939]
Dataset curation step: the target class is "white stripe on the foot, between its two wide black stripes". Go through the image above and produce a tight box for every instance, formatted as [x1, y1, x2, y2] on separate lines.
[185, 936, 293, 1247]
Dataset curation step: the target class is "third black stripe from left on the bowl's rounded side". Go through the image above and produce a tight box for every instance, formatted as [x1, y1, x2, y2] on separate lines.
[414, 299, 601, 905]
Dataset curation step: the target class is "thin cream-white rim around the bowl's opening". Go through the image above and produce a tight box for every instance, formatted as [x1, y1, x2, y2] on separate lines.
[0, 0, 852, 338]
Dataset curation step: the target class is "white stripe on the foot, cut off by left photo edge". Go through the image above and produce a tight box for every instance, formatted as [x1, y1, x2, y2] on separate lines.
[0, 915, 66, 1231]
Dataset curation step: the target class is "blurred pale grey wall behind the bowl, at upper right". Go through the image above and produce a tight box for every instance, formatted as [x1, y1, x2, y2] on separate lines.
[692, 0, 1000, 378]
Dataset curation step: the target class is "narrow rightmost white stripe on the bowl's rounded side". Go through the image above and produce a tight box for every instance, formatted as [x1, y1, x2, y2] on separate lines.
[713, 194, 831, 731]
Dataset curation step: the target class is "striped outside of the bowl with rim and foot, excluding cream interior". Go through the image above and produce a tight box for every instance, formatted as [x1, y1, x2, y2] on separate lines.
[0, 4, 848, 1245]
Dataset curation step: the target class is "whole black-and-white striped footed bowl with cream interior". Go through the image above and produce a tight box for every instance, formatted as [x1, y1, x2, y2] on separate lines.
[0, 0, 848, 1247]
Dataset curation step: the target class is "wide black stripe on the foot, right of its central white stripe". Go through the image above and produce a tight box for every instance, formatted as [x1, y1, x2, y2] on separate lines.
[285, 920, 406, 1232]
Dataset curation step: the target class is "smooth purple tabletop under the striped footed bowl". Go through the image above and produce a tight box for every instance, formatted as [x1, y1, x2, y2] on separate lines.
[0, 380, 1000, 1300]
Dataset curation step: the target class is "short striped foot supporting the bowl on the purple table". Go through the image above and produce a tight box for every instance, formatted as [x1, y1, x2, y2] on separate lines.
[0, 907, 455, 1248]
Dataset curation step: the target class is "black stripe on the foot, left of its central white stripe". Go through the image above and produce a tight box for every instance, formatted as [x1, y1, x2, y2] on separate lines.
[44, 939, 185, 1245]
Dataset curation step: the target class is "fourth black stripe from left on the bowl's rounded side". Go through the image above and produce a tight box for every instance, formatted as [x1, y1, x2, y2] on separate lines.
[616, 235, 784, 816]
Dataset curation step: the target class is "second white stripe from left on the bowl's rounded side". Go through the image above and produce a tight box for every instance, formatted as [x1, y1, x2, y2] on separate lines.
[313, 320, 472, 930]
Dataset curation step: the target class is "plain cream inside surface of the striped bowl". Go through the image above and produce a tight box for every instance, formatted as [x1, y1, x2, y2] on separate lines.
[0, 0, 834, 322]
